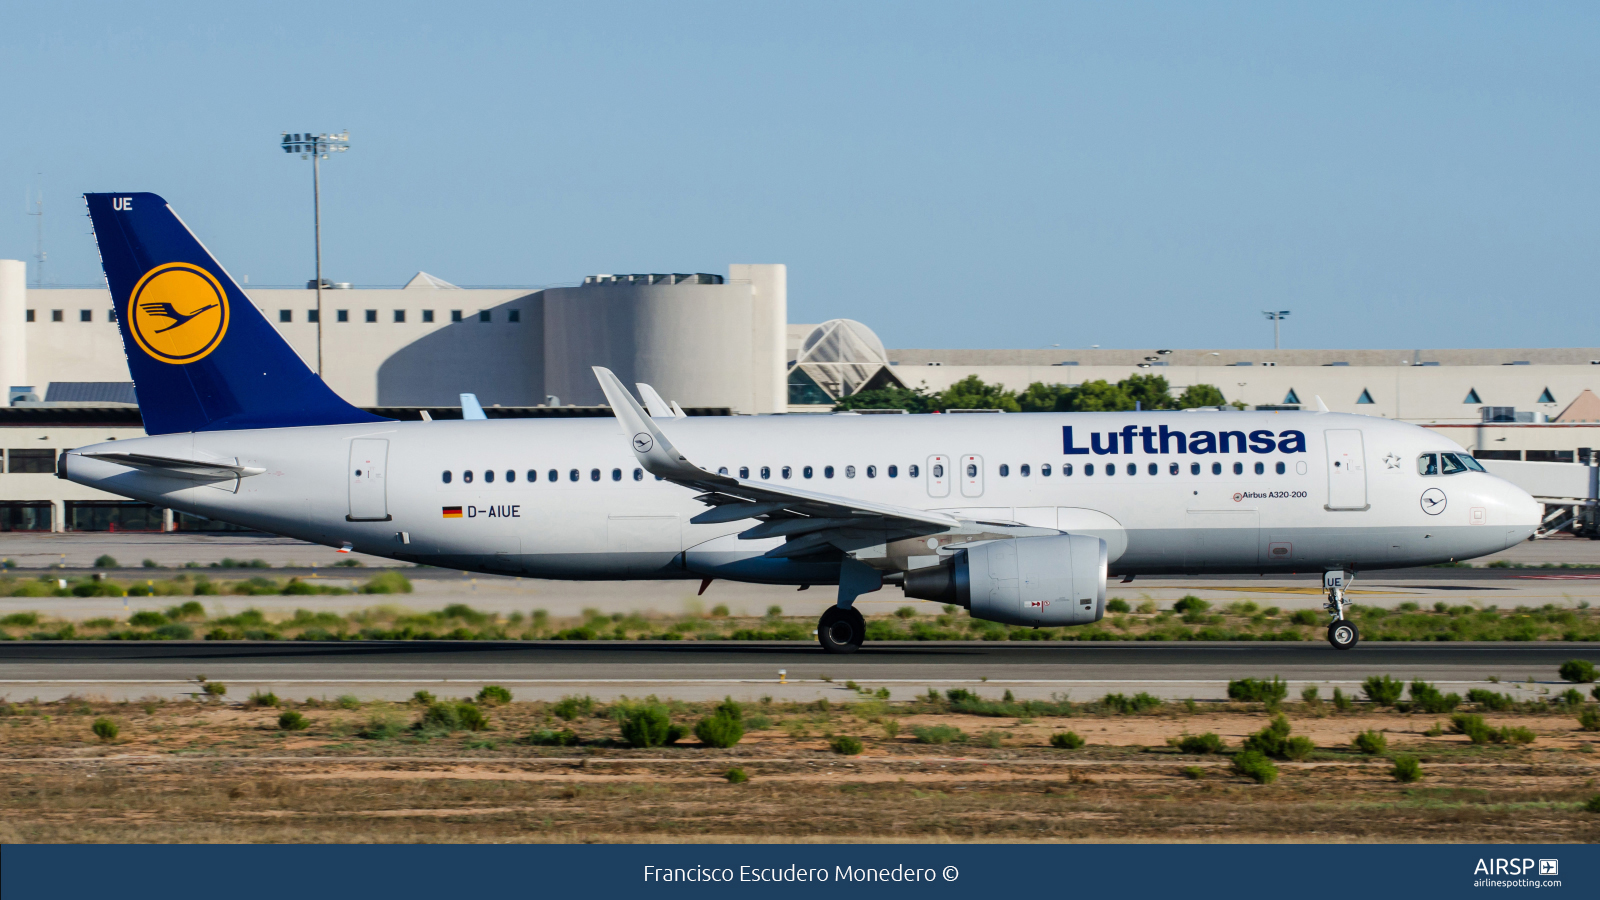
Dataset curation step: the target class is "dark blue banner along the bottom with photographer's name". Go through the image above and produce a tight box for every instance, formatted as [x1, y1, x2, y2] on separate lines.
[0, 844, 1600, 900]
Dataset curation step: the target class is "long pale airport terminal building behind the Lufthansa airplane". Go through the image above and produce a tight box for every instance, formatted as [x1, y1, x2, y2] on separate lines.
[0, 261, 1600, 530]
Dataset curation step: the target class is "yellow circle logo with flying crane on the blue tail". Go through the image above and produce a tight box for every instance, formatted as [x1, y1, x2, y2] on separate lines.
[128, 263, 227, 365]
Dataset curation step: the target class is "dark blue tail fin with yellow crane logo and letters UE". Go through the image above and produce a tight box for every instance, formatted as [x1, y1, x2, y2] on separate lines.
[83, 194, 387, 434]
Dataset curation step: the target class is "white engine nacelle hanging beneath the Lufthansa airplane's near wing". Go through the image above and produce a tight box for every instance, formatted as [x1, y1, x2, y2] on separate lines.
[906, 535, 1106, 628]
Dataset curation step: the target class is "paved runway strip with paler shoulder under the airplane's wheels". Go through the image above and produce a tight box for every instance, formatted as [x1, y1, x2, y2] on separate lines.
[0, 642, 1600, 701]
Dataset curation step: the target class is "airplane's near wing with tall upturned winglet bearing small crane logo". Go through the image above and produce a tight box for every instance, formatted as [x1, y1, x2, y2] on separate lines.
[594, 365, 962, 556]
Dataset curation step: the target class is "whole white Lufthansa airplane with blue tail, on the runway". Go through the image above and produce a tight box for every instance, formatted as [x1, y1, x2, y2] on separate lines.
[58, 194, 1541, 653]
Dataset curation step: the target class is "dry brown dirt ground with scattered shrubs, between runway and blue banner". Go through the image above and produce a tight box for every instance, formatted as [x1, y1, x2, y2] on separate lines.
[0, 700, 1600, 842]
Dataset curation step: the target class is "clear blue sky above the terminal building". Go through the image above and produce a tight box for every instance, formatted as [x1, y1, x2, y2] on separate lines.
[0, 0, 1600, 349]
